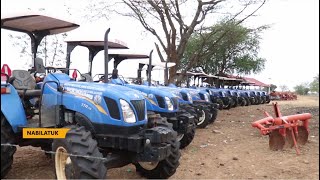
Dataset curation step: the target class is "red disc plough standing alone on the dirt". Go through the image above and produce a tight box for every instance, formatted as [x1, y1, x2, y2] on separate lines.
[252, 103, 311, 154]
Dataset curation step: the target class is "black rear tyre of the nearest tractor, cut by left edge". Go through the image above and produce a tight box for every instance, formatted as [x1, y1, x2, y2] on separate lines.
[1, 114, 17, 179]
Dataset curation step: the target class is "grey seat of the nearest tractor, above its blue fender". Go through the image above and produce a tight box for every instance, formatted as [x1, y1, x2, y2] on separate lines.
[12, 70, 41, 97]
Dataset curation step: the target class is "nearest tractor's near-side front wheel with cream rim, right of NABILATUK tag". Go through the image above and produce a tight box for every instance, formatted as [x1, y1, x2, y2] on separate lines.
[52, 126, 107, 179]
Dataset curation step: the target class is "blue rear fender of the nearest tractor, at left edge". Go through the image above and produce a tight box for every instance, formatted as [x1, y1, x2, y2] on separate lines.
[1, 84, 27, 133]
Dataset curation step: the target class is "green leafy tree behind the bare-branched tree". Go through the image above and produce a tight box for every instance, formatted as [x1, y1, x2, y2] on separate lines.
[179, 20, 267, 75]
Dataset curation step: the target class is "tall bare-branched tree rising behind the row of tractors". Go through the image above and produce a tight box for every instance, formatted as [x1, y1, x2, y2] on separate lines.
[123, 0, 265, 82]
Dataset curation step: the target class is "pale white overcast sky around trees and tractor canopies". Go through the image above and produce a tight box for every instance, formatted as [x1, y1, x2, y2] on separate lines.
[1, 0, 319, 90]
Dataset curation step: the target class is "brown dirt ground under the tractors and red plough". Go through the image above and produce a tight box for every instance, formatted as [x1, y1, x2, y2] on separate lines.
[6, 96, 319, 179]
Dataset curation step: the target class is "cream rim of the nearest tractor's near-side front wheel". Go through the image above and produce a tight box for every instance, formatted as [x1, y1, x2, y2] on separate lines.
[55, 146, 72, 179]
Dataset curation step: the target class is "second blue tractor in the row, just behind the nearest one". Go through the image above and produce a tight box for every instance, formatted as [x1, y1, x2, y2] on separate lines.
[63, 37, 196, 148]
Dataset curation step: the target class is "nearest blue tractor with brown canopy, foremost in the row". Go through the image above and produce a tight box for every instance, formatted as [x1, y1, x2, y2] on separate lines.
[1, 13, 180, 179]
